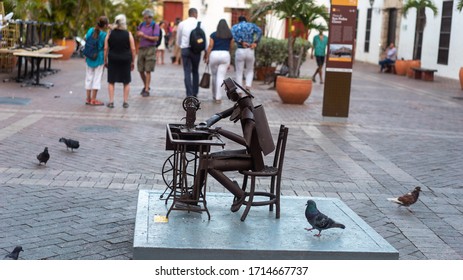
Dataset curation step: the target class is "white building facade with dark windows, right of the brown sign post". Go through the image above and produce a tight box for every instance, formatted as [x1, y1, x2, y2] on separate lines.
[355, 0, 463, 79]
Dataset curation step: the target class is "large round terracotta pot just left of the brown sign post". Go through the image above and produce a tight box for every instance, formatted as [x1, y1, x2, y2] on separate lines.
[276, 76, 312, 104]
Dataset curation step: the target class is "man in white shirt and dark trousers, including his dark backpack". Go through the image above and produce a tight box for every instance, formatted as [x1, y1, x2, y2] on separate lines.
[177, 8, 207, 97]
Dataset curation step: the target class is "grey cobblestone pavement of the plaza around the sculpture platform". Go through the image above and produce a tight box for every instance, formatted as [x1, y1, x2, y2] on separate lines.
[0, 54, 463, 259]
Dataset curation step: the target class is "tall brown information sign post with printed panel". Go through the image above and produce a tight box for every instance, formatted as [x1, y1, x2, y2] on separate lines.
[322, 0, 357, 118]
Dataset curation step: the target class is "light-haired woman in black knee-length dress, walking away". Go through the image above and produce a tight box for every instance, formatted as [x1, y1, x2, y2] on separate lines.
[104, 14, 135, 108]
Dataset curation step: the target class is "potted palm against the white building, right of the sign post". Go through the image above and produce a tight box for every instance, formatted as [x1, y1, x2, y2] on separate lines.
[402, 0, 437, 78]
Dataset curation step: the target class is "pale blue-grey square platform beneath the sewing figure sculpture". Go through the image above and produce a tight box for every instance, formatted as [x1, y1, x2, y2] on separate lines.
[133, 190, 399, 260]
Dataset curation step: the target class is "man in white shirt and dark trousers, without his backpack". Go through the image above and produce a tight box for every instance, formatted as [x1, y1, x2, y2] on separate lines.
[177, 8, 206, 96]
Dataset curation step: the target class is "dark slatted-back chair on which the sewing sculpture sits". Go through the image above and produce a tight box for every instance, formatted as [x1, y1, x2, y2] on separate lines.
[240, 125, 288, 221]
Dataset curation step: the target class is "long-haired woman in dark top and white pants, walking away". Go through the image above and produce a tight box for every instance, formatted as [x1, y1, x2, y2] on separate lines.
[204, 19, 233, 104]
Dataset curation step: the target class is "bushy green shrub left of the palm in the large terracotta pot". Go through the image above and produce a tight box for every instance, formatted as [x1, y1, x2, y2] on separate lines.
[255, 37, 286, 81]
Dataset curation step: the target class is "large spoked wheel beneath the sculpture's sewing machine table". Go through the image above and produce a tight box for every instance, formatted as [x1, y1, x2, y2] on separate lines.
[160, 151, 199, 199]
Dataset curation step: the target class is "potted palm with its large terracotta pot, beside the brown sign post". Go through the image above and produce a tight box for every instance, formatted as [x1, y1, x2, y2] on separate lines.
[254, 0, 329, 104]
